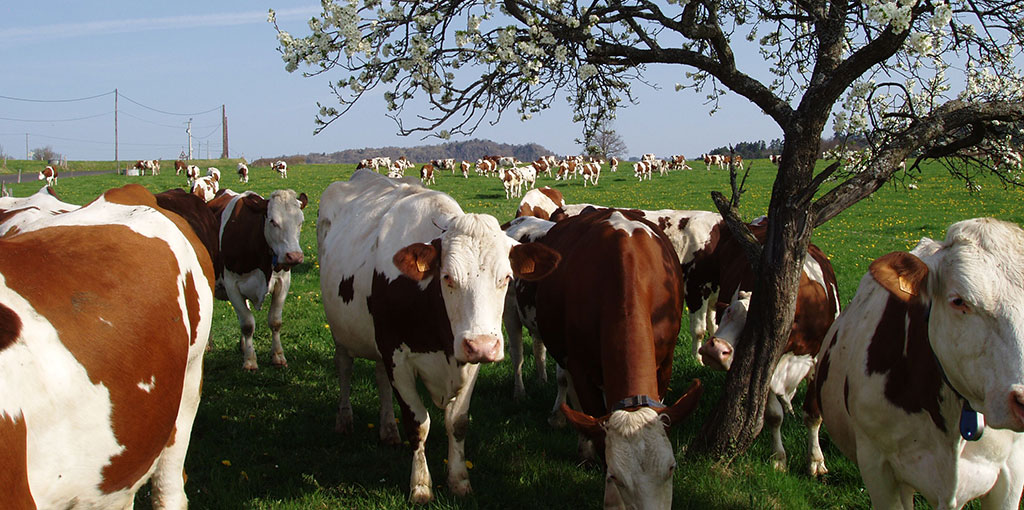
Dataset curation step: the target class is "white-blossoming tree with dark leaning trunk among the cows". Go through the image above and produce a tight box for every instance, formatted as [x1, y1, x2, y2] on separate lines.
[269, 0, 1024, 459]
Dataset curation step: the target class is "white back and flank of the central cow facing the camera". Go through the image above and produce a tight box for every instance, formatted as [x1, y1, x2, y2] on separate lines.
[316, 169, 462, 359]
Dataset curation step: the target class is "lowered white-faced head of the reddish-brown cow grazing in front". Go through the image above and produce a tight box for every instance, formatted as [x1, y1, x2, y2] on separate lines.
[562, 379, 703, 510]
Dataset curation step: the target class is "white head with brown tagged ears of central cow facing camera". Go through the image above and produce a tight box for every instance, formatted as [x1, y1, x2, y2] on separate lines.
[392, 214, 561, 363]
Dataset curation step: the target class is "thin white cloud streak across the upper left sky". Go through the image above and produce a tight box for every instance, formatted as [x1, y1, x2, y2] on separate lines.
[0, 7, 321, 46]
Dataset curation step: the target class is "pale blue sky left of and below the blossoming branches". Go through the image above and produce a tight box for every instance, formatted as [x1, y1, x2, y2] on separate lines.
[0, 0, 781, 160]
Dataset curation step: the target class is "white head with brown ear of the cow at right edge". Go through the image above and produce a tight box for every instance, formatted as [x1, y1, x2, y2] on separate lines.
[870, 218, 1024, 432]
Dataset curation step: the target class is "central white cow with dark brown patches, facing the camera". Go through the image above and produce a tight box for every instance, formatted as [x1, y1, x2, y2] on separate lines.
[316, 170, 558, 503]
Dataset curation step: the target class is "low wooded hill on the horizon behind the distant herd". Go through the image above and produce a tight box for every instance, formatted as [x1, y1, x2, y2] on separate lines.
[253, 139, 554, 166]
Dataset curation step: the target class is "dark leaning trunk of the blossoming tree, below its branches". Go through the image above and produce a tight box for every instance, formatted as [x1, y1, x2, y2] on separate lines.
[688, 137, 819, 461]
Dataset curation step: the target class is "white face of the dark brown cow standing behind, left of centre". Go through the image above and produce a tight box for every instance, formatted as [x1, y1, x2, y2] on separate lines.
[263, 189, 308, 271]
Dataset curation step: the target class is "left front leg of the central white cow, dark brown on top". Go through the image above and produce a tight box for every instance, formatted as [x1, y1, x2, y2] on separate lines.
[391, 362, 434, 504]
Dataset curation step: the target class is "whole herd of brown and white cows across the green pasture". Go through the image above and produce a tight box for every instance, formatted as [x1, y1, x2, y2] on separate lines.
[0, 155, 1024, 509]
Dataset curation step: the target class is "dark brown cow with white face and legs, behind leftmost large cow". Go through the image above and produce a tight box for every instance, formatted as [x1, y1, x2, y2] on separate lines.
[207, 189, 309, 372]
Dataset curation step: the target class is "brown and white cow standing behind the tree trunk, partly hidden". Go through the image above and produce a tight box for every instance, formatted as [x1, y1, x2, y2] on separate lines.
[687, 233, 840, 476]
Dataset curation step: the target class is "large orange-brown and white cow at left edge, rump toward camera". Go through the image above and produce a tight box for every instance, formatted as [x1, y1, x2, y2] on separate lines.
[0, 184, 213, 509]
